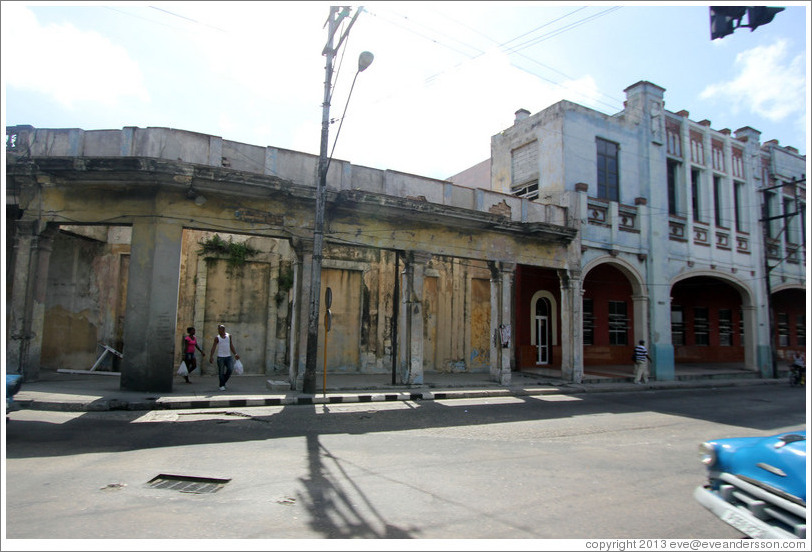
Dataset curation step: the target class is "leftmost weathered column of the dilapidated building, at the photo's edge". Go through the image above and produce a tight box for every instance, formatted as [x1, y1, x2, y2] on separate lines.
[6, 221, 57, 381]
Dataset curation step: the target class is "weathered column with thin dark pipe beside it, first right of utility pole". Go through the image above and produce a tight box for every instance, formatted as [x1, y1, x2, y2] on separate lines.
[398, 251, 431, 385]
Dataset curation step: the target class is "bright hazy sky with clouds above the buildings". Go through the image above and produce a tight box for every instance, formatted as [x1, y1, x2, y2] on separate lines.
[0, 0, 810, 179]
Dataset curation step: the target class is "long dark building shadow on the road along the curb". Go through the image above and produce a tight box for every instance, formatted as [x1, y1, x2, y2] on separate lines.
[6, 385, 806, 458]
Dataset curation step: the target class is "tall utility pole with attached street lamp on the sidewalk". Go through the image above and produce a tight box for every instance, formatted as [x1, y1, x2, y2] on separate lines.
[302, 6, 374, 394]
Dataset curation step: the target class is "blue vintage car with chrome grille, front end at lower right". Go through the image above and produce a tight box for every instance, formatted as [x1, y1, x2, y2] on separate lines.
[694, 430, 806, 539]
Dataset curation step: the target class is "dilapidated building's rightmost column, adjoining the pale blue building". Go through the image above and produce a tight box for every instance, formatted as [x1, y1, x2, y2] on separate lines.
[558, 270, 584, 383]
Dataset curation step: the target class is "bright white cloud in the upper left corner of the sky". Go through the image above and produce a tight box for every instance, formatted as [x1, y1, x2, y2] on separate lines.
[2, 2, 149, 108]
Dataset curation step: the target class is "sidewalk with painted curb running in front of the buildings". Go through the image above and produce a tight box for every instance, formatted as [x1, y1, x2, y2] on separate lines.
[9, 365, 786, 411]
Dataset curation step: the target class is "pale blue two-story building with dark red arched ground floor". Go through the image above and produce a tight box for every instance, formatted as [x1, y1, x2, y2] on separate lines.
[450, 82, 806, 381]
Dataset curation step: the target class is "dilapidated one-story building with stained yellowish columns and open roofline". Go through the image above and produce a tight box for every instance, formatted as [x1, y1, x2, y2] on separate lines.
[5, 126, 585, 391]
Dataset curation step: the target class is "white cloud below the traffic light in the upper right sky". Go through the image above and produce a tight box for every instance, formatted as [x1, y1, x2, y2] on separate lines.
[700, 40, 806, 121]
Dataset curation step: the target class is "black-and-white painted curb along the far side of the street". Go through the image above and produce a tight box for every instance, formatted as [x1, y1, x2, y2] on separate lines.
[15, 379, 784, 412]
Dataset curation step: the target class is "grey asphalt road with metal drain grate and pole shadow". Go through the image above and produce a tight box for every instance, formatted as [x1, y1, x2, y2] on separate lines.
[5, 385, 807, 550]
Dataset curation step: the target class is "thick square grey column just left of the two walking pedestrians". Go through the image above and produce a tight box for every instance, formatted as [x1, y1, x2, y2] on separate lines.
[121, 218, 183, 392]
